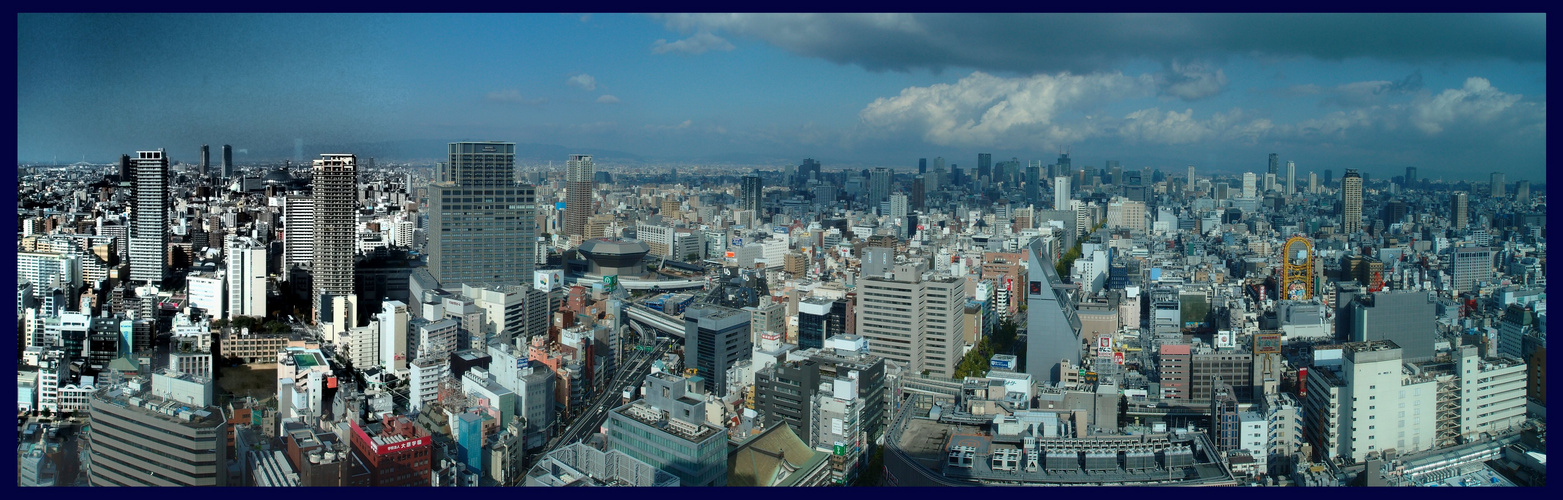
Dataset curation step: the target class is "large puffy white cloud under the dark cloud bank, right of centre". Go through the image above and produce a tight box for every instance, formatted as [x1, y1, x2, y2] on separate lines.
[858, 72, 1155, 148]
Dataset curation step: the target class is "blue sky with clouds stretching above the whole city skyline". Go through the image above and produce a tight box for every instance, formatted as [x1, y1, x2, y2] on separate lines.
[17, 14, 1547, 181]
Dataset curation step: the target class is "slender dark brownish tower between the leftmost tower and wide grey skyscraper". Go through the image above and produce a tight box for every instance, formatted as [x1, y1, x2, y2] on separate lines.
[309, 155, 358, 319]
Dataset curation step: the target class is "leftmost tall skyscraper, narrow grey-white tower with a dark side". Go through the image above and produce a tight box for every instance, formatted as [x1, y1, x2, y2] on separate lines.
[130, 150, 169, 284]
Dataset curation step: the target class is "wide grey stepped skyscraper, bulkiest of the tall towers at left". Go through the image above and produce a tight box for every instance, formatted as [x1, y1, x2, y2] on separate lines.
[428, 142, 538, 288]
